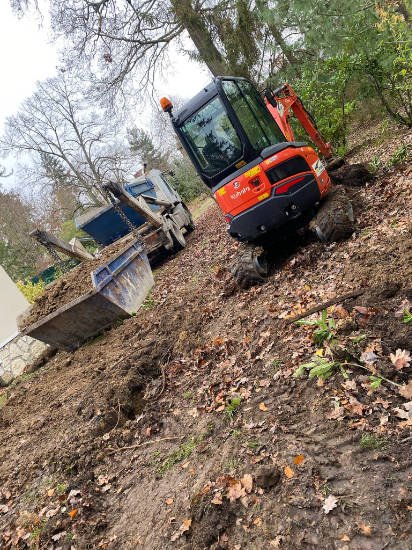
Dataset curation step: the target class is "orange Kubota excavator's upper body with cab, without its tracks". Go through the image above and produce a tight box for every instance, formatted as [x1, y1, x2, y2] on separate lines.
[161, 77, 331, 242]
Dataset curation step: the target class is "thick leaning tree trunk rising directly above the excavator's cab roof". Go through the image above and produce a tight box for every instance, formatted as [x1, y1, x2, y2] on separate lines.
[172, 0, 228, 76]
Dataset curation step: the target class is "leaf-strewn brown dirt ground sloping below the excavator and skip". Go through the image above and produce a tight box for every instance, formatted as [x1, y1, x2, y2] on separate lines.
[0, 130, 412, 550]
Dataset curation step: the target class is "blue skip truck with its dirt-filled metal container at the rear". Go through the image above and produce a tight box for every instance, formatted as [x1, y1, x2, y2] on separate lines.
[18, 170, 194, 349]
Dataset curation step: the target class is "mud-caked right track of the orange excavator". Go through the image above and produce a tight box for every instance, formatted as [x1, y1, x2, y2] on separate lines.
[311, 187, 355, 242]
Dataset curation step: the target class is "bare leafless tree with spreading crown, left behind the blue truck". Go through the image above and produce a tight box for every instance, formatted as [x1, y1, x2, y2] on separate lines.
[0, 73, 132, 204]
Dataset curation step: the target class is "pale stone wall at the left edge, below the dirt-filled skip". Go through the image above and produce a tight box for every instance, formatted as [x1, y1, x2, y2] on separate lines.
[0, 335, 48, 386]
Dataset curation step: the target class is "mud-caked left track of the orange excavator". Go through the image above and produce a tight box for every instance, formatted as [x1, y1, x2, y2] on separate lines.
[231, 244, 269, 288]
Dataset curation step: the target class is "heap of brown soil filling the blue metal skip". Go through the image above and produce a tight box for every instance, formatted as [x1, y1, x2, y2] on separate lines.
[19, 236, 133, 331]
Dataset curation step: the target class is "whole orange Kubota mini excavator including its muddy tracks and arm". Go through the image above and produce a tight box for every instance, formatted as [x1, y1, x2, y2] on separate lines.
[160, 76, 354, 287]
